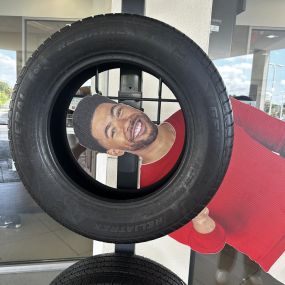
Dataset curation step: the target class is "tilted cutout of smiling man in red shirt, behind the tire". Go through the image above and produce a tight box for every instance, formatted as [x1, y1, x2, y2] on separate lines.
[73, 95, 285, 283]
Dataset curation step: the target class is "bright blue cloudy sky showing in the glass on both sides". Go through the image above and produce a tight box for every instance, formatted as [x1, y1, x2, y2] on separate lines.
[0, 49, 285, 104]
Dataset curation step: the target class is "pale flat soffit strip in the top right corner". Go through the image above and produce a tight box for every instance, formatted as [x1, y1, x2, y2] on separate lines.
[237, 0, 285, 28]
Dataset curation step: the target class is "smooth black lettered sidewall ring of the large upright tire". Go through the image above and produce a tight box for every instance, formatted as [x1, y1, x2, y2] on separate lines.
[12, 14, 230, 242]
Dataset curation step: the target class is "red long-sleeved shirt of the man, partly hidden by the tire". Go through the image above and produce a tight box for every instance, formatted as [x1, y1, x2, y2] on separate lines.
[141, 99, 285, 271]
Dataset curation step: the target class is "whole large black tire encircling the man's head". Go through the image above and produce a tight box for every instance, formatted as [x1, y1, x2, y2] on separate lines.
[9, 14, 233, 243]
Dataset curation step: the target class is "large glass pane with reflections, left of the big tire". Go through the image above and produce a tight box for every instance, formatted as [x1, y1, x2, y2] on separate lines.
[0, 16, 93, 265]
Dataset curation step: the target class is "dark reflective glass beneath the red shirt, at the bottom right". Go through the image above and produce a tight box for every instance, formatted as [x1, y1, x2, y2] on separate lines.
[193, 246, 282, 285]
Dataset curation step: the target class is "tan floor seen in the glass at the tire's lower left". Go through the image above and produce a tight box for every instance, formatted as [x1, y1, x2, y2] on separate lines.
[0, 213, 92, 262]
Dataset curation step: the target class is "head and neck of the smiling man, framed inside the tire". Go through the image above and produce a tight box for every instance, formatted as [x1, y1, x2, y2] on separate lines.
[73, 95, 175, 163]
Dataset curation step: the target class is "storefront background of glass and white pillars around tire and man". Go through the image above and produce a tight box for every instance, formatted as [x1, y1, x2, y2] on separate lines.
[0, 0, 285, 285]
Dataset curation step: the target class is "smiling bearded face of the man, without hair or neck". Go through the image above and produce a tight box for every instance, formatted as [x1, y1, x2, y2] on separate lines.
[91, 103, 158, 151]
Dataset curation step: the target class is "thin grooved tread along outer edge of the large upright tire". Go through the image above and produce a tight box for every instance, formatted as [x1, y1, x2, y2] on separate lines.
[8, 14, 234, 243]
